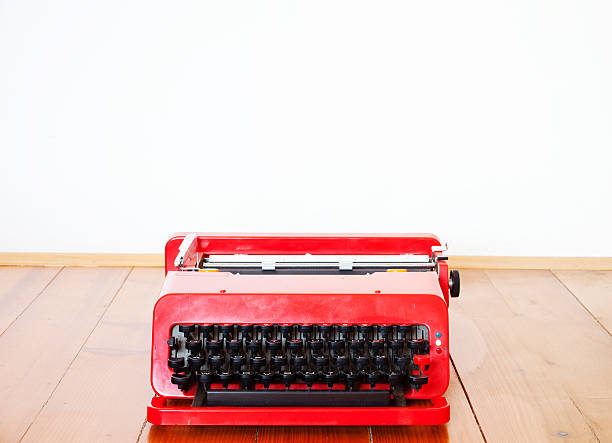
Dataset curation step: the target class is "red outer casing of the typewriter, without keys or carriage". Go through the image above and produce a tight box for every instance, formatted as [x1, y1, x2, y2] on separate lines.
[147, 234, 449, 425]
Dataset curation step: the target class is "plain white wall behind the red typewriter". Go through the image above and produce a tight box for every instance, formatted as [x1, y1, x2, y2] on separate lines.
[0, 0, 612, 256]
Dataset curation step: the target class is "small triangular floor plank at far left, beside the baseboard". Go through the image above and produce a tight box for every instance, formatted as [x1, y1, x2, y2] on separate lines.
[0, 266, 62, 335]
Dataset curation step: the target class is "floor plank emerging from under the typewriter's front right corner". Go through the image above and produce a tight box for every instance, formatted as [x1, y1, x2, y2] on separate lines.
[371, 367, 484, 443]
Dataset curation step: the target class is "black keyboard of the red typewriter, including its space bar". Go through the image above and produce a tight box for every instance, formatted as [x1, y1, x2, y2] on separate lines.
[168, 324, 429, 405]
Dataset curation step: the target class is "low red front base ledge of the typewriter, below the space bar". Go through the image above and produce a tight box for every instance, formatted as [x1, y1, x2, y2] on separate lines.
[147, 397, 450, 426]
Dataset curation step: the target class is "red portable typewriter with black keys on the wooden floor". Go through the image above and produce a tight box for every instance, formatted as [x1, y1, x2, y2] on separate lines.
[147, 234, 459, 425]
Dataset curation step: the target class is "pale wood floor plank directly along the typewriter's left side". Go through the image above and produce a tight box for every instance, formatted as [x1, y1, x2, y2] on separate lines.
[23, 268, 164, 442]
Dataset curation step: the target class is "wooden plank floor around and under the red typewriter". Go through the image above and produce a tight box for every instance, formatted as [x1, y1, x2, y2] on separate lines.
[0, 267, 612, 443]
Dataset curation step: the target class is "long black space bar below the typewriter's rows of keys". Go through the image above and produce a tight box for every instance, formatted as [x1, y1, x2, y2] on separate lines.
[206, 390, 390, 407]
